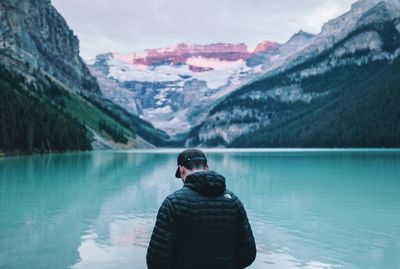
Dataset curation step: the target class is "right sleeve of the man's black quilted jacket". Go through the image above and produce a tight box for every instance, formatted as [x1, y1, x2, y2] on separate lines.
[237, 200, 257, 268]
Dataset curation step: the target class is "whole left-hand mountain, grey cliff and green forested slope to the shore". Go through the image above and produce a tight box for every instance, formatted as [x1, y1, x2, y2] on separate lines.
[0, 0, 165, 151]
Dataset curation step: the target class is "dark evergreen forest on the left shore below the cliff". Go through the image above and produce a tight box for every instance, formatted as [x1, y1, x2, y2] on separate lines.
[0, 63, 92, 154]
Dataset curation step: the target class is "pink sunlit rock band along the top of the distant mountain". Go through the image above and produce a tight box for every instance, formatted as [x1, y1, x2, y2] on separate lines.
[132, 41, 278, 67]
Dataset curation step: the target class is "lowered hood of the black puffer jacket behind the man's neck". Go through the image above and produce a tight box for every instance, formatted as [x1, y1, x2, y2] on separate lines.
[184, 171, 226, 196]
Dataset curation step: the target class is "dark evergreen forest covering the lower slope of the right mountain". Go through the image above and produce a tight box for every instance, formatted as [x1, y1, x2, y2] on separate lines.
[229, 57, 400, 148]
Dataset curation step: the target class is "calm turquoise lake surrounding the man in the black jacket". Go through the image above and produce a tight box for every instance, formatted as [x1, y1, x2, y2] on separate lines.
[0, 150, 400, 269]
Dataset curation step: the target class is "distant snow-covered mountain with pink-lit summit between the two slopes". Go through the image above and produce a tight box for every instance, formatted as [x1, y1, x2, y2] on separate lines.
[89, 41, 281, 135]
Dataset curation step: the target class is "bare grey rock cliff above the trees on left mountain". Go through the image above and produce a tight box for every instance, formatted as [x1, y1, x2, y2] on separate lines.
[0, 0, 101, 94]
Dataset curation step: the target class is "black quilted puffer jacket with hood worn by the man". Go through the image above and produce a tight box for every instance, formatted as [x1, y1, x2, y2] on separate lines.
[147, 171, 256, 269]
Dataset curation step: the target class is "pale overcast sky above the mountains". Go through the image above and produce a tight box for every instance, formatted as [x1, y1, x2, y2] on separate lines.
[52, 0, 355, 60]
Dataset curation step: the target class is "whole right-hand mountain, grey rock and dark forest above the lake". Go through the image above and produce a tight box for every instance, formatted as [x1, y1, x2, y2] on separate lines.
[186, 0, 400, 146]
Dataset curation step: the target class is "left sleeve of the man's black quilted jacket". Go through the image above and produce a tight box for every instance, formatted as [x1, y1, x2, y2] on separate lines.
[146, 198, 176, 269]
